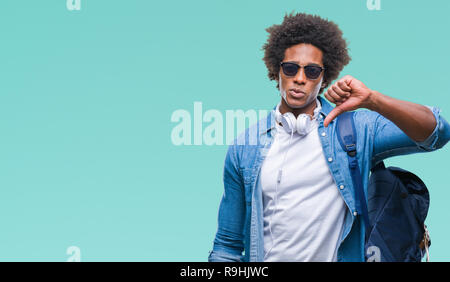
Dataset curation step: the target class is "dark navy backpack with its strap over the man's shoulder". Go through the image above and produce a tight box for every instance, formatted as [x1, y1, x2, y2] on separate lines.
[337, 112, 431, 262]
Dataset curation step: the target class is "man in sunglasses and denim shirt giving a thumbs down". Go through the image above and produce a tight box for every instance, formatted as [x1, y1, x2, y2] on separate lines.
[208, 13, 450, 261]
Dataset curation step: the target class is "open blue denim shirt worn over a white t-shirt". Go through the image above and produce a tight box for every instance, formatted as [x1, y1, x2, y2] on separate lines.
[208, 96, 450, 262]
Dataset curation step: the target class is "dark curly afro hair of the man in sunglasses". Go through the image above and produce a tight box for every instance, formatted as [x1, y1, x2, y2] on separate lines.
[262, 12, 351, 93]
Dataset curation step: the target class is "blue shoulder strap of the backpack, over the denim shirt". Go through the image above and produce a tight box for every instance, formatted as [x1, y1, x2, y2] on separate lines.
[337, 112, 370, 235]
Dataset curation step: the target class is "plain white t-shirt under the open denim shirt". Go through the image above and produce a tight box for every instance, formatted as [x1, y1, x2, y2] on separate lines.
[260, 102, 346, 261]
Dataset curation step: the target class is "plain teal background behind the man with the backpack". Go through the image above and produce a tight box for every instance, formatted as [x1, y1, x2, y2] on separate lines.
[0, 0, 450, 261]
